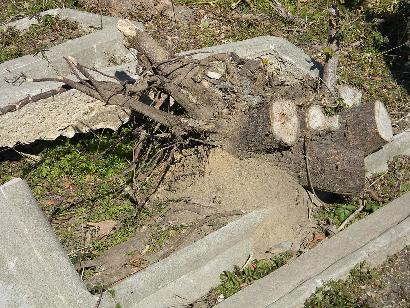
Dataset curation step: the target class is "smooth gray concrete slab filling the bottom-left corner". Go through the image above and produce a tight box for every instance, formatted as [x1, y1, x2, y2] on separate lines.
[0, 179, 96, 308]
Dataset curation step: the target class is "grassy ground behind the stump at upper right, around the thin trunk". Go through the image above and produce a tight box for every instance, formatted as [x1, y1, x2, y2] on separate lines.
[168, 0, 410, 120]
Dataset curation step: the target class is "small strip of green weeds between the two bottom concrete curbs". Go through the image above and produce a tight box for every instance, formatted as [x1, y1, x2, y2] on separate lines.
[215, 253, 292, 298]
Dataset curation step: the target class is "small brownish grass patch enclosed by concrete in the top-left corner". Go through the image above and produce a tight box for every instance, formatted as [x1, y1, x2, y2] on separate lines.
[0, 15, 82, 63]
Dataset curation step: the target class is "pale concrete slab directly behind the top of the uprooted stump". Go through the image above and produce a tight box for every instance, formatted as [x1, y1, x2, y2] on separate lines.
[182, 36, 322, 78]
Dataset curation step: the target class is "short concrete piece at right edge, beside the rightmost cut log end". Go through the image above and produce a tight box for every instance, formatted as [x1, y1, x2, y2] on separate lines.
[364, 130, 410, 176]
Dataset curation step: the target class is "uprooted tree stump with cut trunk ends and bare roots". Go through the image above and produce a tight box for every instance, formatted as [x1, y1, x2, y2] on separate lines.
[22, 21, 392, 194]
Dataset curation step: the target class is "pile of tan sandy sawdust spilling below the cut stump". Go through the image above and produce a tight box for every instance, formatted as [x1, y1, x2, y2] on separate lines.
[160, 149, 313, 257]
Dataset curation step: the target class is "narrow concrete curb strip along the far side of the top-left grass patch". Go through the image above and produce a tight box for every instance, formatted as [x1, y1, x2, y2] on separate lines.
[3, 8, 119, 31]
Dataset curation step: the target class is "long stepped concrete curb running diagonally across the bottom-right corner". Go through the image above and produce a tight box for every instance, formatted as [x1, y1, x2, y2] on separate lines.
[216, 193, 410, 308]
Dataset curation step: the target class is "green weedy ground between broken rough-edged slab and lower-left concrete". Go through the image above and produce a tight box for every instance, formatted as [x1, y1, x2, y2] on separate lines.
[0, 125, 160, 262]
